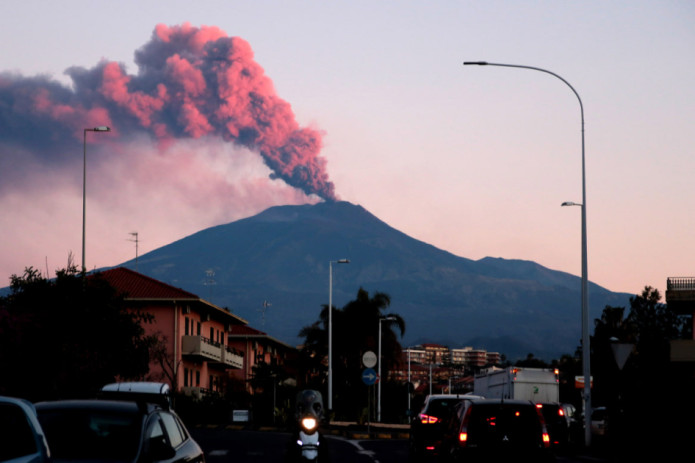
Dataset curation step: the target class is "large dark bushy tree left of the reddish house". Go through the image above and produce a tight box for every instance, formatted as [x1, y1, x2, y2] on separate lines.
[0, 266, 156, 401]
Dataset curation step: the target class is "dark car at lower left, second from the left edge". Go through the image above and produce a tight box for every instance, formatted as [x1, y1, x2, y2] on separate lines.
[35, 382, 205, 463]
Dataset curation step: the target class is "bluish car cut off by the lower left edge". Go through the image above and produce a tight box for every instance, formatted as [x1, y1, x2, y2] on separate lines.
[0, 396, 50, 463]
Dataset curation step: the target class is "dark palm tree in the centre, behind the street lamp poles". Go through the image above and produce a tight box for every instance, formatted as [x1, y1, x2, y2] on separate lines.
[299, 288, 405, 421]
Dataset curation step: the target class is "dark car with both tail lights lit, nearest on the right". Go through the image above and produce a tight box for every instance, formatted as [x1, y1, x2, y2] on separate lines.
[442, 399, 554, 462]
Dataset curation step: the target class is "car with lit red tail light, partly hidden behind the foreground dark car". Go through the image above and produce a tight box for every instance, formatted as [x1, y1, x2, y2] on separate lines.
[409, 394, 480, 461]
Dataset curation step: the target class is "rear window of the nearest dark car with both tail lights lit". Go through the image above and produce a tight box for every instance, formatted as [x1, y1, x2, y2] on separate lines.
[468, 404, 542, 446]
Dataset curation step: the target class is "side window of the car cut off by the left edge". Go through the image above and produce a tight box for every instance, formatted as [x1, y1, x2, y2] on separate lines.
[0, 403, 38, 461]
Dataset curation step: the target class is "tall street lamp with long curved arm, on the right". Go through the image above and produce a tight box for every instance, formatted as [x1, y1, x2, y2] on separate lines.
[463, 61, 591, 446]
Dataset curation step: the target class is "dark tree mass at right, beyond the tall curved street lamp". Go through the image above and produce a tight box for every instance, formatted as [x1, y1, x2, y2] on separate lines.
[591, 286, 688, 451]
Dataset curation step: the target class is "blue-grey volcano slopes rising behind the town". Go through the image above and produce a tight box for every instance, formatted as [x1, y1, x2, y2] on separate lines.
[117, 202, 629, 360]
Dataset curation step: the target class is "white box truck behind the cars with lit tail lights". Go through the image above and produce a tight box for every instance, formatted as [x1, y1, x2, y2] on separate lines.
[473, 367, 560, 403]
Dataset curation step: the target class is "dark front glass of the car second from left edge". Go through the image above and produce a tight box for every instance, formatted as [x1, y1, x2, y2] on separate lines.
[39, 408, 141, 462]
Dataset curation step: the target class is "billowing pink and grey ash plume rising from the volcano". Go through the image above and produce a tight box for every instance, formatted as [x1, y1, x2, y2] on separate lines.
[0, 24, 335, 200]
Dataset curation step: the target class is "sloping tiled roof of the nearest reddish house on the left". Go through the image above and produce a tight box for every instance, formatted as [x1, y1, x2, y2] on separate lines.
[96, 267, 200, 300]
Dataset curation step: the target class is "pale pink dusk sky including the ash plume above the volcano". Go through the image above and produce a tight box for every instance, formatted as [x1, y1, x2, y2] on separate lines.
[0, 0, 695, 300]
